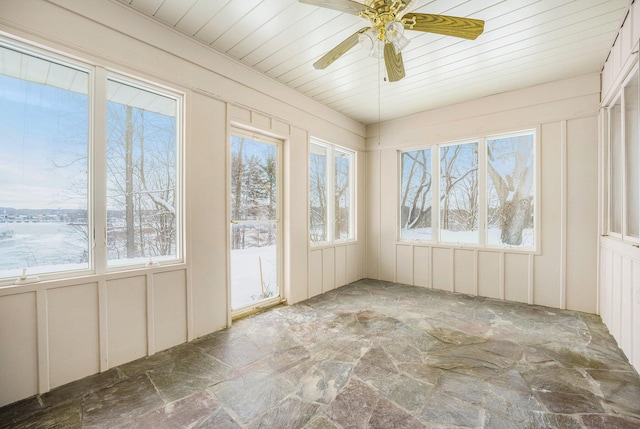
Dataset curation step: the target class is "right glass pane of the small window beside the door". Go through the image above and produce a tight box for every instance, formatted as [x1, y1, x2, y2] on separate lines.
[334, 150, 352, 240]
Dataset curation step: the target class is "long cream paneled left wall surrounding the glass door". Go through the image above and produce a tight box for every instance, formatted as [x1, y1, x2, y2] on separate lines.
[0, 0, 366, 406]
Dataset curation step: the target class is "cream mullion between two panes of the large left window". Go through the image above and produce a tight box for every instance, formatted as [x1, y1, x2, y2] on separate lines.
[89, 68, 107, 273]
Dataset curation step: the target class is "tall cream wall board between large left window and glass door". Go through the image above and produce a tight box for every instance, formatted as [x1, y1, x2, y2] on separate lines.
[186, 93, 228, 338]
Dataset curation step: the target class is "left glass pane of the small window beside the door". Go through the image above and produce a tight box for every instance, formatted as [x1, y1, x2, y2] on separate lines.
[309, 143, 328, 243]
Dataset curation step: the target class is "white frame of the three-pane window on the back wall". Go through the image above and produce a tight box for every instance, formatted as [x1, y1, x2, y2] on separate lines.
[396, 126, 541, 254]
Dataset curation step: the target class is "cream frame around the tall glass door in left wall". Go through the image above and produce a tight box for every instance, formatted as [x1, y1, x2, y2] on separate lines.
[226, 125, 286, 320]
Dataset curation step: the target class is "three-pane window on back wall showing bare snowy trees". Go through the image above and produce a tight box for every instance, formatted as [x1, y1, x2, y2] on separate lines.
[399, 131, 536, 250]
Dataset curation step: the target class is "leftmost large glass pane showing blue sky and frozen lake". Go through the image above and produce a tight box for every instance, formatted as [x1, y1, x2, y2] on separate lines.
[0, 47, 90, 277]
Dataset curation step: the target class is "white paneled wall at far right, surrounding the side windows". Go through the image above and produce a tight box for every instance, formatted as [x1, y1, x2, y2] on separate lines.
[598, 2, 640, 372]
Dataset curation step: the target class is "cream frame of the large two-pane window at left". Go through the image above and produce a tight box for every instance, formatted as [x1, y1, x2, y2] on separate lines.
[0, 35, 186, 288]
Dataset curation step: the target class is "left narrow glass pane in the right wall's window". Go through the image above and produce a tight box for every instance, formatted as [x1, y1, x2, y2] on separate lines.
[609, 101, 623, 234]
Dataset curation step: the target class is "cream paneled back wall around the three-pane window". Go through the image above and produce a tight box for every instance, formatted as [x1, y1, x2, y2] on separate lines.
[366, 74, 600, 313]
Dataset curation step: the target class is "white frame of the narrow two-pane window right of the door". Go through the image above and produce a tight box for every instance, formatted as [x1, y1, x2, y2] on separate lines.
[307, 137, 357, 247]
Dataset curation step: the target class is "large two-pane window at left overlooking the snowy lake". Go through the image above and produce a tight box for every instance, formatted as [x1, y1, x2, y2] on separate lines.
[0, 40, 181, 284]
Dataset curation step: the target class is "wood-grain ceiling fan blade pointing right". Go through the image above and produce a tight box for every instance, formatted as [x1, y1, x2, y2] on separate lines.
[402, 13, 484, 40]
